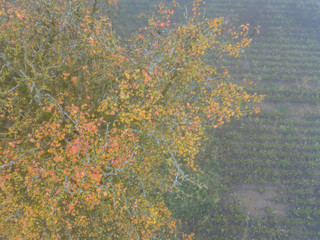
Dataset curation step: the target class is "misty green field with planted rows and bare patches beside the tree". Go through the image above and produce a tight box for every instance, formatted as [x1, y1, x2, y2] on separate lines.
[114, 0, 320, 239]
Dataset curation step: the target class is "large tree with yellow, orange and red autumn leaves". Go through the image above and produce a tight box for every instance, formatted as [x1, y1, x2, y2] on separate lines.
[0, 0, 261, 239]
